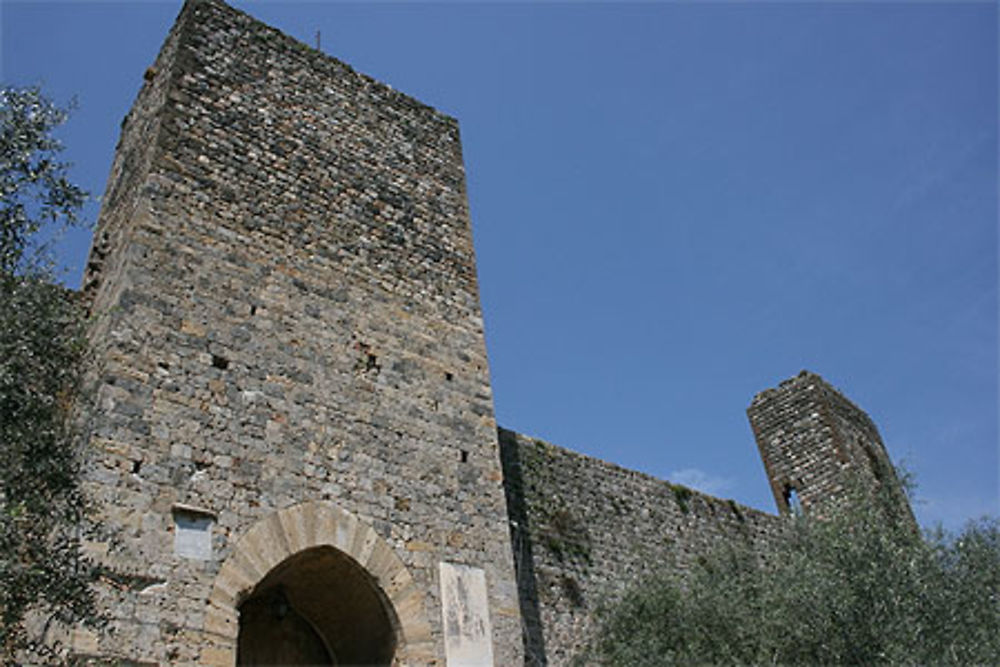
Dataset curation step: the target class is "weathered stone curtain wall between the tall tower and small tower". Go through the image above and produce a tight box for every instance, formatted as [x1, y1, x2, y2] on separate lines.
[500, 429, 781, 665]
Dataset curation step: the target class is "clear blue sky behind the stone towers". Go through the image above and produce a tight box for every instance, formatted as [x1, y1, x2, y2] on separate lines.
[0, 0, 1000, 528]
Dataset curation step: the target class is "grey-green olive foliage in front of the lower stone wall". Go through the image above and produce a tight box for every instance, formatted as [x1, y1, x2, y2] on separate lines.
[589, 482, 1000, 667]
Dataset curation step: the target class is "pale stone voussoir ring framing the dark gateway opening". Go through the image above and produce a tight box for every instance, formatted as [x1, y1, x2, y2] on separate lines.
[200, 502, 434, 665]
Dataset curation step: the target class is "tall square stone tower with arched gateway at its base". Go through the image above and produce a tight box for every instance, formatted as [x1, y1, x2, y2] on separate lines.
[74, 0, 522, 665]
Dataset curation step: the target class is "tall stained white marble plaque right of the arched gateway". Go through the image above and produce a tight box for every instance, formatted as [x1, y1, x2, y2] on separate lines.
[440, 562, 493, 667]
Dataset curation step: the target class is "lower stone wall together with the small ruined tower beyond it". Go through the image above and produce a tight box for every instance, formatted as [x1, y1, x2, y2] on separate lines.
[500, 371, 915, 665]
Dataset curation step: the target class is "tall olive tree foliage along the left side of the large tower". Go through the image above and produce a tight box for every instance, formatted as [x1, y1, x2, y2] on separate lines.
[0, 88, 97, 664]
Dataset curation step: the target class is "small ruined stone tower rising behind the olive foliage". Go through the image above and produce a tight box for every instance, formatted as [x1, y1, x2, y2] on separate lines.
[747, 371, 899, 514]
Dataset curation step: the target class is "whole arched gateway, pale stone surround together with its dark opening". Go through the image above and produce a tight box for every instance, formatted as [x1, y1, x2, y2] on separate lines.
[204, 502, 433, 665]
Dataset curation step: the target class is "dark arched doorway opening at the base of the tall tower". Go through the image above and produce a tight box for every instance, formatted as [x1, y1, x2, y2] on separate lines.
[236, 547, 397, 666]
